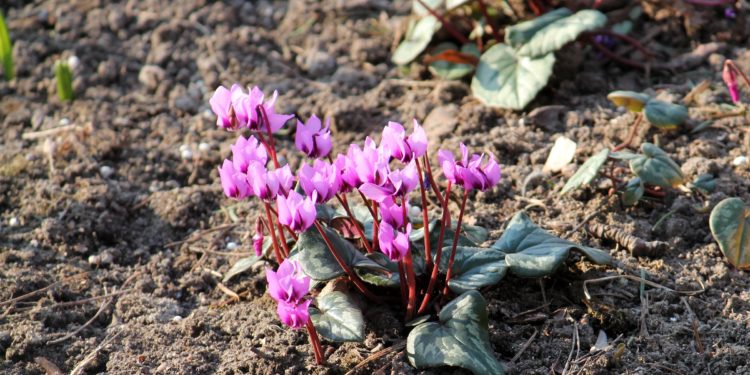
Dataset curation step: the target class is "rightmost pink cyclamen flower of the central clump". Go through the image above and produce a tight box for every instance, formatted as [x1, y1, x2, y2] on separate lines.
[438, 143, 500, 191]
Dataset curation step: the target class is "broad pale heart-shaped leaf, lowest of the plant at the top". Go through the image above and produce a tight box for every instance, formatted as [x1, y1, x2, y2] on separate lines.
[471, 44, 555, 109]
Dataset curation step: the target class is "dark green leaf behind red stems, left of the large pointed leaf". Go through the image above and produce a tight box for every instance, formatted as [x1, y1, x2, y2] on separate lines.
[440, 246, 508, 294]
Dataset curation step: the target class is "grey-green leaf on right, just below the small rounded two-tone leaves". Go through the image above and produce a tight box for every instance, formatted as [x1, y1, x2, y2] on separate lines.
[630, 142, 685, 188]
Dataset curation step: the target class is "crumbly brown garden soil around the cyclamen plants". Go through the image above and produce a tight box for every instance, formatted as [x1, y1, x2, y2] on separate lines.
[0, 0, 750, 374]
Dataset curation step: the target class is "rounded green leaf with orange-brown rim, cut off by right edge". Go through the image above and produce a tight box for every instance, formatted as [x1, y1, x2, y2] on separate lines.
[708, 198, 750, 270]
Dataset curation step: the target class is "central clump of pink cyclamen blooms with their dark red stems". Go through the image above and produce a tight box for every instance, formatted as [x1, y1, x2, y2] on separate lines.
[210, 84, 500, 364]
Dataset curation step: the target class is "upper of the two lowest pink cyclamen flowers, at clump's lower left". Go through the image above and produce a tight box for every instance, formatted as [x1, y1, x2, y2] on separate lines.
[266, 259, 310, 303]
